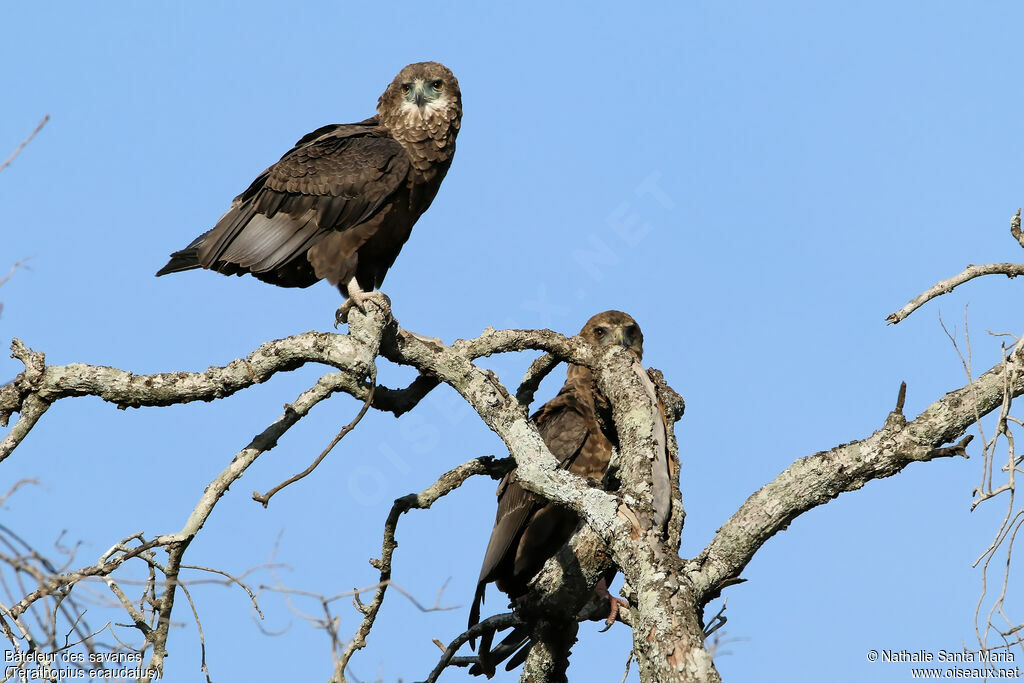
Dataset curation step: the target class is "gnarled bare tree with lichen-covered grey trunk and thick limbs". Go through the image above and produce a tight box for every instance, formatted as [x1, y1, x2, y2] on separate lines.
[0, 259, 1024, 682]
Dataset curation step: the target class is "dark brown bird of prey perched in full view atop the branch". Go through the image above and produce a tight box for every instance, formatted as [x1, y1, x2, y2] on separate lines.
[157, 61, 462, 319]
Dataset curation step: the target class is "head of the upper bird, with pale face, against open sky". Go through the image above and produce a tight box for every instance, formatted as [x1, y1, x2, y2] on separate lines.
[377, 61, 462, 120]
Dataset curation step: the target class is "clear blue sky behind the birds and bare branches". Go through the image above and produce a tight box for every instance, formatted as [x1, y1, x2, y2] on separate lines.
[0, 2, 1024, 681]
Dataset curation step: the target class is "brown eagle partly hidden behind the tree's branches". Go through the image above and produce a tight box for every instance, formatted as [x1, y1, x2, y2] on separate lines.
[469, 310, 643, 675]
